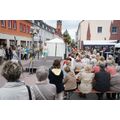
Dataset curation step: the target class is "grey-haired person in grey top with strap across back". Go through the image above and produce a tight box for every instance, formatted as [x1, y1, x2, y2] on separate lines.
[32, 66, 56, 100]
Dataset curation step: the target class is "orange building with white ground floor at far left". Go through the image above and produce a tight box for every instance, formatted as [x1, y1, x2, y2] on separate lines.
[0, 20, 32, 47]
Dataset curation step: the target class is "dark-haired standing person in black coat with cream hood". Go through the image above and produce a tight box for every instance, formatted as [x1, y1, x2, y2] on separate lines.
[48, 60, 64, 100]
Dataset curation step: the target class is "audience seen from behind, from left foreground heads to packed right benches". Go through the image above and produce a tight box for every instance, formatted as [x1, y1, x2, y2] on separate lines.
[0, 46, 120, 100]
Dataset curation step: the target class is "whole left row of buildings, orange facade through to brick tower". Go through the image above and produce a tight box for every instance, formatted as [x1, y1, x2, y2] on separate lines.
[0, 20, 62, 48]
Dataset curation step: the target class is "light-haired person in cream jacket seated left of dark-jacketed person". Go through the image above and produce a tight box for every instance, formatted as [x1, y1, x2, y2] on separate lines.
[79, 65, 94, 94]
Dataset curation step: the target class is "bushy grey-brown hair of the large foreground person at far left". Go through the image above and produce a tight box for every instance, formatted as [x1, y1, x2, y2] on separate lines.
[2, 61, 22, 82]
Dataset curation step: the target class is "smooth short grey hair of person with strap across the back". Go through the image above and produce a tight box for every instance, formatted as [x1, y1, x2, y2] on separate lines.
[36, 66, 48, 81]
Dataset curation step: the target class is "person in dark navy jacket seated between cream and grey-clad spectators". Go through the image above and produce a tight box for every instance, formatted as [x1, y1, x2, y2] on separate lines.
[94, 64, 111, 100]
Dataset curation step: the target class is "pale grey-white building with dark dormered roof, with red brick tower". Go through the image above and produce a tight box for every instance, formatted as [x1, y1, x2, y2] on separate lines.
[31, 20, 62, 49]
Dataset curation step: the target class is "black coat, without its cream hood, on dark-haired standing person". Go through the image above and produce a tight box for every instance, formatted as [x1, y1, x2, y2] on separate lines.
[48, 69, 64, 93]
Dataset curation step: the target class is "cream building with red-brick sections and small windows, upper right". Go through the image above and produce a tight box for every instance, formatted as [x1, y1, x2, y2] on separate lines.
[76, 20, 120, 41]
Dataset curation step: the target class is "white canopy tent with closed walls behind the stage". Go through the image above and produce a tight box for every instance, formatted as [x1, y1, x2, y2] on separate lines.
[46, 38, 65, 58]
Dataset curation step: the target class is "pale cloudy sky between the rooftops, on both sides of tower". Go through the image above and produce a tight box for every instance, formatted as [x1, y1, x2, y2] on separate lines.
[43, 20, 80, 39]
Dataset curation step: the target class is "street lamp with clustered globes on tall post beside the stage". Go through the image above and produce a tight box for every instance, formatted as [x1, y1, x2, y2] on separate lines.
[29, 26, 38, 74]
